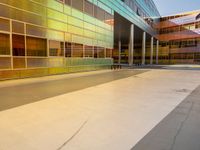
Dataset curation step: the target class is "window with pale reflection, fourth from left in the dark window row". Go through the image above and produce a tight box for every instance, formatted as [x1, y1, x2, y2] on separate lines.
[49, 41, 64, 56]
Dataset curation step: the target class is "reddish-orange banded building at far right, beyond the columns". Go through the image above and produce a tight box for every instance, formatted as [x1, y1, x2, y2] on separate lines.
[155, 11, 200, 64]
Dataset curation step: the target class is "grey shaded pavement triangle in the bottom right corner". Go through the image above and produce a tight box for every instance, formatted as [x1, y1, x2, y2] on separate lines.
[132, 86, 200, 150]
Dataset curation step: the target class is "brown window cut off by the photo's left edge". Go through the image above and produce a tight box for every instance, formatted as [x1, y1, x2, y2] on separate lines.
[0, 33, 10, 55]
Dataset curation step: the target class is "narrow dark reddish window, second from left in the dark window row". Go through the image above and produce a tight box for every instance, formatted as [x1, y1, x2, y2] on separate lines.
[12, 34, 25, 56]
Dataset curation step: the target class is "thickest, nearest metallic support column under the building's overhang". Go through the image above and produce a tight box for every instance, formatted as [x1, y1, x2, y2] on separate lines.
[128, 24, 134, 66]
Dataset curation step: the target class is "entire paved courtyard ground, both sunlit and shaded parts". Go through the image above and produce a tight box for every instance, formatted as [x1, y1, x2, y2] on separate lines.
[0, 65, 200, 150]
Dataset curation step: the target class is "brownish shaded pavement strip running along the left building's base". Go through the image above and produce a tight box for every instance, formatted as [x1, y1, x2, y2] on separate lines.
[0, 70, 147, 111]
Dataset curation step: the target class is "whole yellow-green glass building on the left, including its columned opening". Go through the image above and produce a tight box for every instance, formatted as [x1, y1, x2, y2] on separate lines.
[0, 0, 160, 79]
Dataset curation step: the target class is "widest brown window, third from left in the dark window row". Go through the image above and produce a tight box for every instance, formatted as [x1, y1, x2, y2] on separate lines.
[26, 37, 47, 56]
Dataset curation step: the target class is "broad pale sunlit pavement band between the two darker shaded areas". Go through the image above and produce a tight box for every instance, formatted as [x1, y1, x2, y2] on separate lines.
[0, 69, 200, 150]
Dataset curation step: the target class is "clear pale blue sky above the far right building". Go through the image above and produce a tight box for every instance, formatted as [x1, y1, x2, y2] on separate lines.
[154, 0, 200, 16]
